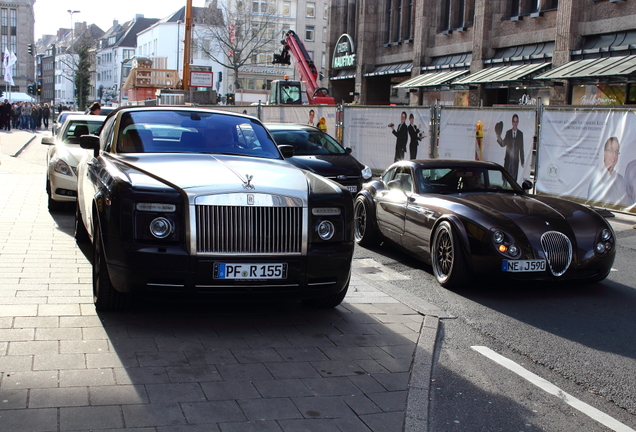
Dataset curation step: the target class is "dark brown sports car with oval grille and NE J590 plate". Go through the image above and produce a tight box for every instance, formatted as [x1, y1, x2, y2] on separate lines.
[354, 160, 616, 287]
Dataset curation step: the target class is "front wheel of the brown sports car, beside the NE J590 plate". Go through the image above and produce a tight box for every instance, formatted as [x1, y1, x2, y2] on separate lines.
[431, 221, 470, 288]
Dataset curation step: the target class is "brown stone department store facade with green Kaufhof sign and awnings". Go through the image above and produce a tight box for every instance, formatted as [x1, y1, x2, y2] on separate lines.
[328, 0, 636, 106]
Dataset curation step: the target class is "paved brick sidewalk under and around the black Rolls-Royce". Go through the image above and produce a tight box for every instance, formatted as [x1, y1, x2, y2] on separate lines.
[0, 131, 443, 432]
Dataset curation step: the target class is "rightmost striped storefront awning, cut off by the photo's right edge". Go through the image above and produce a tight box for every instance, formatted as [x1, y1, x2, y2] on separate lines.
[535, 55, 636, 79]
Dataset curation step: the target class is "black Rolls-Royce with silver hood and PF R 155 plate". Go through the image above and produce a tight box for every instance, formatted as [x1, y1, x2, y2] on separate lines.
[75, 107, 354, 310]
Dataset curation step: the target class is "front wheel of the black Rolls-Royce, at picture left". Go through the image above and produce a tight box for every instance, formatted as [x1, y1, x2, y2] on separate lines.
[93, 222, 130, 311]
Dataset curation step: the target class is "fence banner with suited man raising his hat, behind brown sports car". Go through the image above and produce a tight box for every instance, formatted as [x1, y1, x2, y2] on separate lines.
[437, 107, 536, 183]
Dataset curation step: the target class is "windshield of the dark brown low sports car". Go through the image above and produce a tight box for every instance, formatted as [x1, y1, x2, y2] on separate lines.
[416, 167, 523, 194]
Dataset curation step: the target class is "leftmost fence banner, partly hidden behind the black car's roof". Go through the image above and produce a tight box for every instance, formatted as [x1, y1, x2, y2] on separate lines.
[261, 105, 336, 137]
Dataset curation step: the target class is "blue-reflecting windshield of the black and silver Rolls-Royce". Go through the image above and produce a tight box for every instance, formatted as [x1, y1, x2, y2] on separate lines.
[116, 110, 281, 159]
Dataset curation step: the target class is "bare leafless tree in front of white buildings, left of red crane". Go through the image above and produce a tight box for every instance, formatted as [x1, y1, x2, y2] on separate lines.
[193, 0, 281, 89]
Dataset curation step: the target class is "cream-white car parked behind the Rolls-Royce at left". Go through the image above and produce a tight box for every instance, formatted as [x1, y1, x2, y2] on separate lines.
[42, 114, 106, 210]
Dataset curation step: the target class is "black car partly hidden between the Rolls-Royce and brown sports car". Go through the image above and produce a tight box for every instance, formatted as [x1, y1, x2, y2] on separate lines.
[265, 123, 373, 194]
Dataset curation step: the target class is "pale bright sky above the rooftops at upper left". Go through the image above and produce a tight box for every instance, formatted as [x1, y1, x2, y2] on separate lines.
[33, 0, 205, 40]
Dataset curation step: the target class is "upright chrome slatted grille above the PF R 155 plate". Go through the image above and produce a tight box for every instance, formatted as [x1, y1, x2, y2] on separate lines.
[196, 205, 303, 254]
